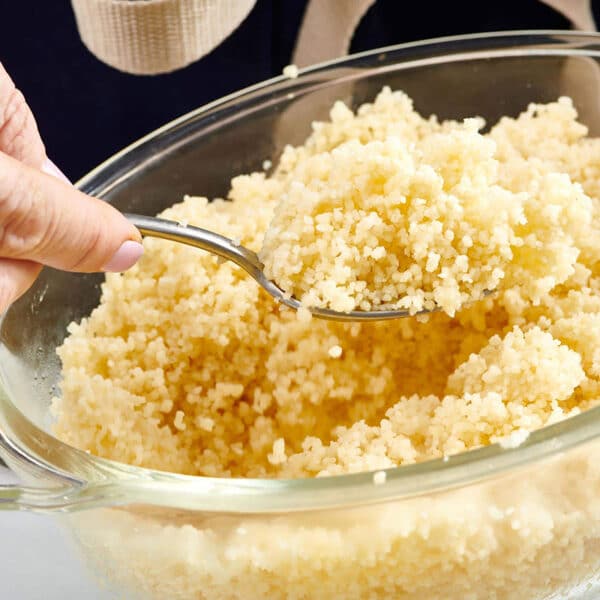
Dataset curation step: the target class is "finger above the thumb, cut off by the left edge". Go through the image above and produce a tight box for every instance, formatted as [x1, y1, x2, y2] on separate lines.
[0, 63, 46, 169]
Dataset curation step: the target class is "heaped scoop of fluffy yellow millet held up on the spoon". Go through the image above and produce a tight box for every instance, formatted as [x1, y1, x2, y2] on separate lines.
[260, 102, 592, 316]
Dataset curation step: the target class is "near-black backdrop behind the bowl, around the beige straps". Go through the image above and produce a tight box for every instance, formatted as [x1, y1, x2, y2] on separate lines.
[0, 0, 584, 180]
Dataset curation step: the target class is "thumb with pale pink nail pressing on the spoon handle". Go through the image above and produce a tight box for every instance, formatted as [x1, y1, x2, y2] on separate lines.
[0, 152, 143, 272]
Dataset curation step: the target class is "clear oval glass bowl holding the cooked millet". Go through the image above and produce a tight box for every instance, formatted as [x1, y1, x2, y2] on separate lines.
[0, 32, 600, 600]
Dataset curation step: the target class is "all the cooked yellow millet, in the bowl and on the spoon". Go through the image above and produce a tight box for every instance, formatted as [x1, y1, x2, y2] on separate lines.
[54, 89, 600, 600]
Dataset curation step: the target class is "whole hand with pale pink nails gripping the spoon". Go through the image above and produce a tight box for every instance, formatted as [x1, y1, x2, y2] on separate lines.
[0, 63, 143, 312]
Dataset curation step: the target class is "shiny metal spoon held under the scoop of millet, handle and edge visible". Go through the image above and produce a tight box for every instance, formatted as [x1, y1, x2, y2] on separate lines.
[125, 214, 437, 321]
